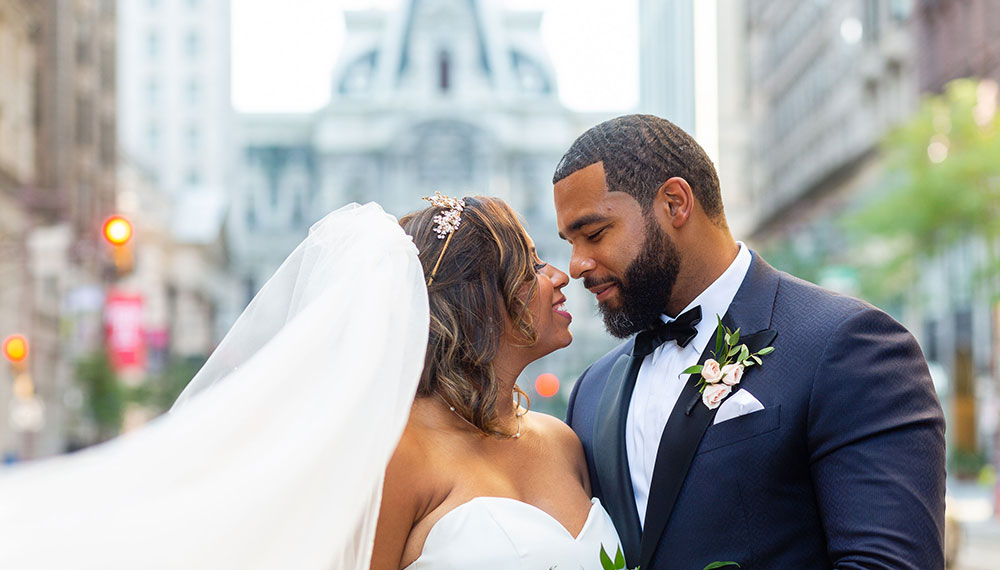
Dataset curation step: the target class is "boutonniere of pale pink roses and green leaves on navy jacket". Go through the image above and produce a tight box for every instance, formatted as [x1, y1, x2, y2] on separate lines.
[682, 315, 774, 410]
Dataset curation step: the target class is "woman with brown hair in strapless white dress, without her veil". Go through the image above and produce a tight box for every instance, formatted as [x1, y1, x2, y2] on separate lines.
[372, 193, 618, 570]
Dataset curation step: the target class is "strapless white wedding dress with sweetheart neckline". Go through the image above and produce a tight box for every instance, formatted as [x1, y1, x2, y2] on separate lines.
[406, 497, 619, 570]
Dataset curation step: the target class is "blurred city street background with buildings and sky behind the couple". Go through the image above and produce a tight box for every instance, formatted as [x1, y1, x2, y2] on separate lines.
[0, 0, 1000, 570]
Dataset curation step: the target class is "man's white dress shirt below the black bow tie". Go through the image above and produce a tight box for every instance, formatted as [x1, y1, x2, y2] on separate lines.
[625, 242, 751, 526]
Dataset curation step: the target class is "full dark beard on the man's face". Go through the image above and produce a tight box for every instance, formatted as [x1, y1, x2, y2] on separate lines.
[584, 216, 680, 338]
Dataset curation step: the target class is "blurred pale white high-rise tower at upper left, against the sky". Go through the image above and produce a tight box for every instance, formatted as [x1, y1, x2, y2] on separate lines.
[118, 0, 235, 199]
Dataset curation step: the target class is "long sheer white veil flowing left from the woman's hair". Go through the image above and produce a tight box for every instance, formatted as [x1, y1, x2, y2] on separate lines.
[0, 203, 429, 570]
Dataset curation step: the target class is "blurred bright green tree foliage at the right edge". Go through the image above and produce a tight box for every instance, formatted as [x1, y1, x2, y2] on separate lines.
[846, 79, 1000, 295]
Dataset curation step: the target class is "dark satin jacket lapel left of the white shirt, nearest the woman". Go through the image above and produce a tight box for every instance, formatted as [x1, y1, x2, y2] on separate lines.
[593, 345, 642, 564]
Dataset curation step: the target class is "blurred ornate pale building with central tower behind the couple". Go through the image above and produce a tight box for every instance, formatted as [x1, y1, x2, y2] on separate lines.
[229, 0, 612, 398]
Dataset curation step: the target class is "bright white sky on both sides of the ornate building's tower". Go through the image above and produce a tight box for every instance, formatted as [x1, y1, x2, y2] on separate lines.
[231, 0, 639, 112]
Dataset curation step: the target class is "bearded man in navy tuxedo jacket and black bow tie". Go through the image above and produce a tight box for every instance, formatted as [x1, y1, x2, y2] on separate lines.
[553, 115, 945, 570]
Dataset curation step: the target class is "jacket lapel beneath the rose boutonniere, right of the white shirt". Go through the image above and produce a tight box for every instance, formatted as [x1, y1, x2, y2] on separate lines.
[636, 255, 778, 568]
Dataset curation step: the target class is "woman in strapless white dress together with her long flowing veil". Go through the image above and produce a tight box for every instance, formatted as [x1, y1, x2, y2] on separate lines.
[0, 198, 618, 570]
